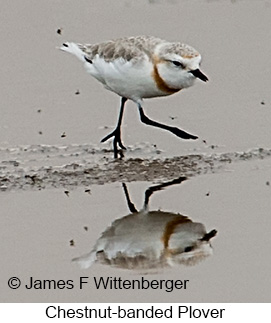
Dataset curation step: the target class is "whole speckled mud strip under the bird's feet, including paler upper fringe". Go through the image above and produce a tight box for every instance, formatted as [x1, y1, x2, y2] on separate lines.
[0, 145, 271, 192]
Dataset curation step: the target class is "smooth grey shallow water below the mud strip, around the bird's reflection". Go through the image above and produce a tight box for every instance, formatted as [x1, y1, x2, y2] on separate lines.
[0, 158, 271, 302]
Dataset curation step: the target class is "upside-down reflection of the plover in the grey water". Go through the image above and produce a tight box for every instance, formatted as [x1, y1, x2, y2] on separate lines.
[74, 177, 217, 270]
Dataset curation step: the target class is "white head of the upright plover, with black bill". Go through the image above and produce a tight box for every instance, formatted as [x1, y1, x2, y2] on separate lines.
[153, 43, 208, 89]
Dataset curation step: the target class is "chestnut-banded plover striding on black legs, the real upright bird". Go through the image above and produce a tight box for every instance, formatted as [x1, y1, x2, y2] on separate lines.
[61, 36, 208, 158]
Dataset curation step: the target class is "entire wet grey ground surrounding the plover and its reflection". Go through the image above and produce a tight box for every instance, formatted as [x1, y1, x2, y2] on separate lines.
[0, 0, 271, 302]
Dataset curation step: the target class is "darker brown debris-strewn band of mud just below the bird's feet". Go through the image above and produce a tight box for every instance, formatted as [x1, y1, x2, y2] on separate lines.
[0, 147, 271, 196]
